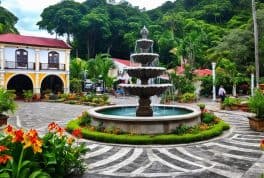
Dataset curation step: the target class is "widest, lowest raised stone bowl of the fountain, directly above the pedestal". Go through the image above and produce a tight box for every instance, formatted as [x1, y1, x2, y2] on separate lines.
[119, 84, 172, 98]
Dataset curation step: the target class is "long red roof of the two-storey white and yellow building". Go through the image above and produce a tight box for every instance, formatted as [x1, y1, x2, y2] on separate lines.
[0, 33, 71, 49]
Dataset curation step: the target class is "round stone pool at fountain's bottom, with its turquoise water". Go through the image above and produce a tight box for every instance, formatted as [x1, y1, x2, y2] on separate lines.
[89, 105, 201, 134]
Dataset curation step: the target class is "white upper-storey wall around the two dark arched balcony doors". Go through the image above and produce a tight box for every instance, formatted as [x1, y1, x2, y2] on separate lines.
[4, 47, 65, 64]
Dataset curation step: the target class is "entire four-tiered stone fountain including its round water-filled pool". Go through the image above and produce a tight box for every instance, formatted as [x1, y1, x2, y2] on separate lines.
[90, 26, 201, 134]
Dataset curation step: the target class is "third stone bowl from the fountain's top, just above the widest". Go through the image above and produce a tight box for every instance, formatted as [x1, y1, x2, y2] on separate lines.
[125, 67, 166, 85]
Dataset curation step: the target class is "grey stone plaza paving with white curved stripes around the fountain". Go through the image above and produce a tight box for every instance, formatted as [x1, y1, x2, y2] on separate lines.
[7, 97, 264, 178]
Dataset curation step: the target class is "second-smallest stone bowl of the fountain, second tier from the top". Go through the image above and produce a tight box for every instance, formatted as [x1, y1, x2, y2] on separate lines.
[130, 53, 159, 66]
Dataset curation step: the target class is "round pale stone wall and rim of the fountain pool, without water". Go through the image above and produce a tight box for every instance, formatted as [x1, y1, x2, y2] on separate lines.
[89, 106, 201, 134]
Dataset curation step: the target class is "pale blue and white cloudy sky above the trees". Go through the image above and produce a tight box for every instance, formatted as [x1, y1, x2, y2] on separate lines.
[1, 0, 176, 38]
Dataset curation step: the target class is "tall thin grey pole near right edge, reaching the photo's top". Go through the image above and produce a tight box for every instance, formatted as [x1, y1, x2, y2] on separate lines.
[252, 0, 259, 88]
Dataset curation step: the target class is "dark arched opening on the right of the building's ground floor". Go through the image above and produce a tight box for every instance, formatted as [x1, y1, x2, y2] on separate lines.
[41, 75, 63, 94]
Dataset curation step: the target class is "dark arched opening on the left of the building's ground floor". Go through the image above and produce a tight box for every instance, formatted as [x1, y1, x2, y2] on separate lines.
[7, 74, 33, 98]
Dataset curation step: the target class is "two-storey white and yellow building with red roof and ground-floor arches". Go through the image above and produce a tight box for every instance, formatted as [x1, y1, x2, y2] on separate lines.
[0, 34, 71, 97]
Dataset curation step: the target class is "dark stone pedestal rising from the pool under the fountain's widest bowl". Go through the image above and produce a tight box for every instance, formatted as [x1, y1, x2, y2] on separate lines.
[136, 97, 153, 117]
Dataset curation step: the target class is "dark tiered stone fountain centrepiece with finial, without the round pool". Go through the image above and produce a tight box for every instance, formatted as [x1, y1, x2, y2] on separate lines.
[120, 26, 171, 116]
